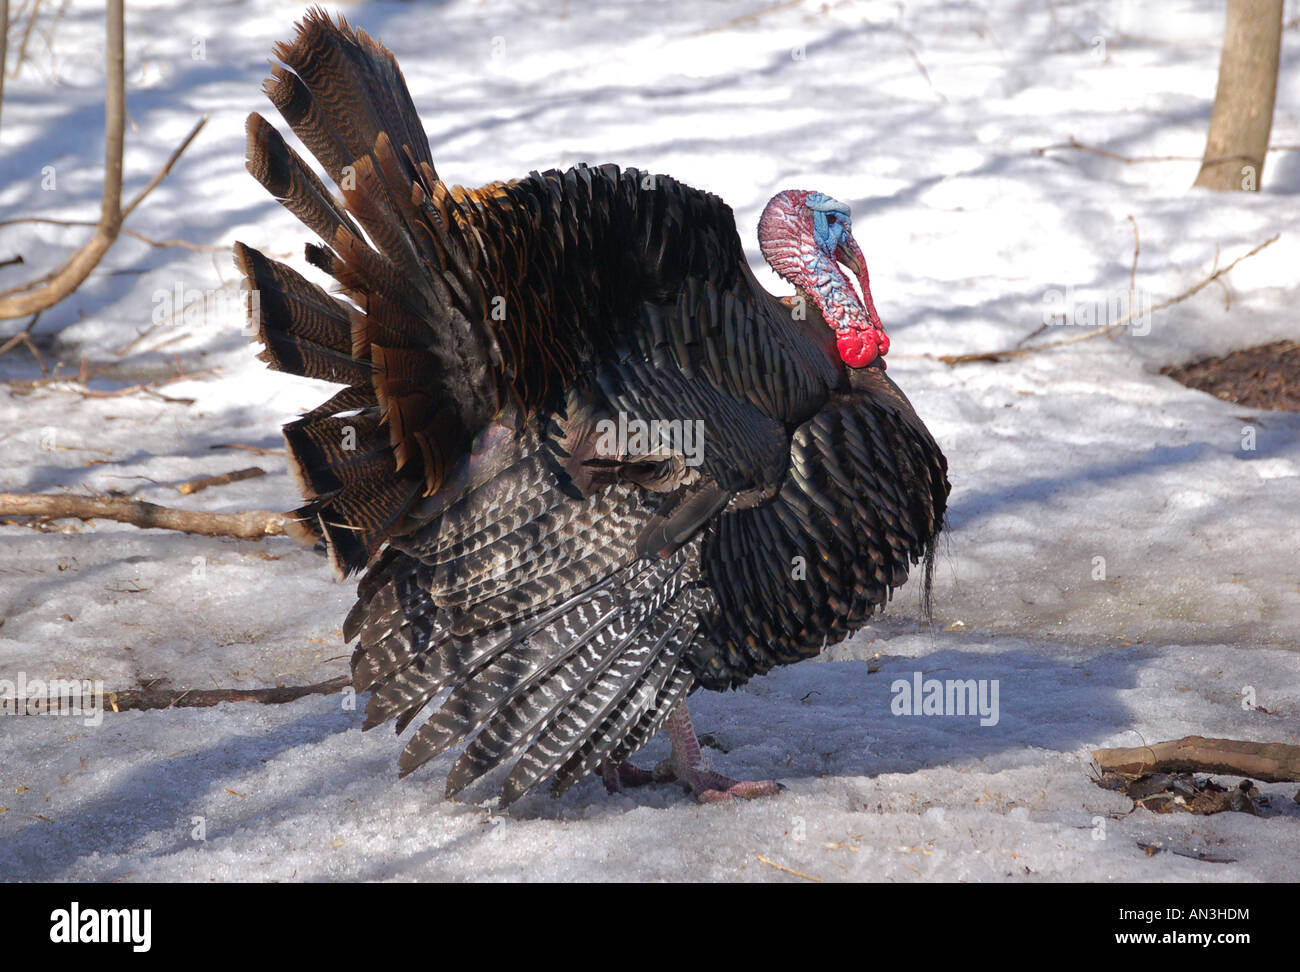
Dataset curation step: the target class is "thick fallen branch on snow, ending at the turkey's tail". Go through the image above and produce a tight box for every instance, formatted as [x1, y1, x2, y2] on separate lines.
[0, 492, 289, 541]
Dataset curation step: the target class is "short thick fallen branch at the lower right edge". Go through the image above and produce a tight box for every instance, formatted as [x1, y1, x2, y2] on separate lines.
[1092, 735, 1300, 784]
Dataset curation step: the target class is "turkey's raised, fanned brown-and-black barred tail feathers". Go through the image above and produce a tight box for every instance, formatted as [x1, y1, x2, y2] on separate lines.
[235, 10, 503, 572]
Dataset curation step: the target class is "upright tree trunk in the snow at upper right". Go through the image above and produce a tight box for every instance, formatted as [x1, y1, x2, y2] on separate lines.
[1196, 0, 1283, 191]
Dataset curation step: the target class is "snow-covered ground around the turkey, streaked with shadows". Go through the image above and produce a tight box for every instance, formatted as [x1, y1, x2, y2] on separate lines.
[0, 0, 1300, 881]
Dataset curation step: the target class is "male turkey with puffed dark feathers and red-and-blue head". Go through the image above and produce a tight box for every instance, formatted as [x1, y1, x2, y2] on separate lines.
[235, 10, 949, 806]
